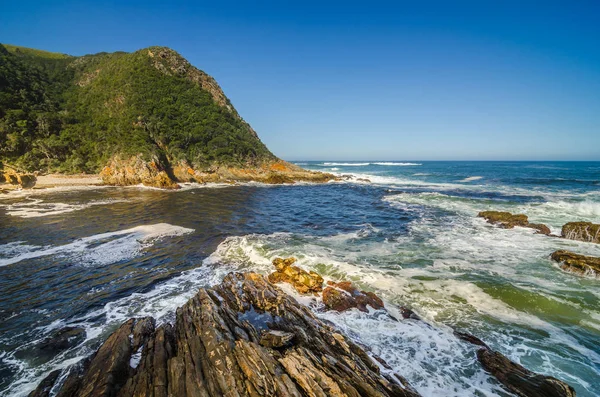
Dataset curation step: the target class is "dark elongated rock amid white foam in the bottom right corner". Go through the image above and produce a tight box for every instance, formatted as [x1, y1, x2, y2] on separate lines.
[477, 348, 575, 397]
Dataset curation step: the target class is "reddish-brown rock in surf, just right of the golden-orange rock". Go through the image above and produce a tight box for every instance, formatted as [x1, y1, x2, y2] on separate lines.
[323, 281, 383, 312]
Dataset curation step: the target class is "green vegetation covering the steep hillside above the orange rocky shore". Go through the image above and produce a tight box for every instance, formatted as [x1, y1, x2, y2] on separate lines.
[0, 45, 275, 173]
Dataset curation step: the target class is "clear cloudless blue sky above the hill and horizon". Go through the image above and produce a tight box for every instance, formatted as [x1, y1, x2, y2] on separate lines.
[0, 0, 600, 160]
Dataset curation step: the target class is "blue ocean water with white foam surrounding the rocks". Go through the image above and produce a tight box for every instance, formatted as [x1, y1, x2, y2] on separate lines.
[0, 161, 600, 397]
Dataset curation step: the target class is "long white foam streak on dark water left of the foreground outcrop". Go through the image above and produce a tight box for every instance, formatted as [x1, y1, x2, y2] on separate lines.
[0, 223, 194, 267]
